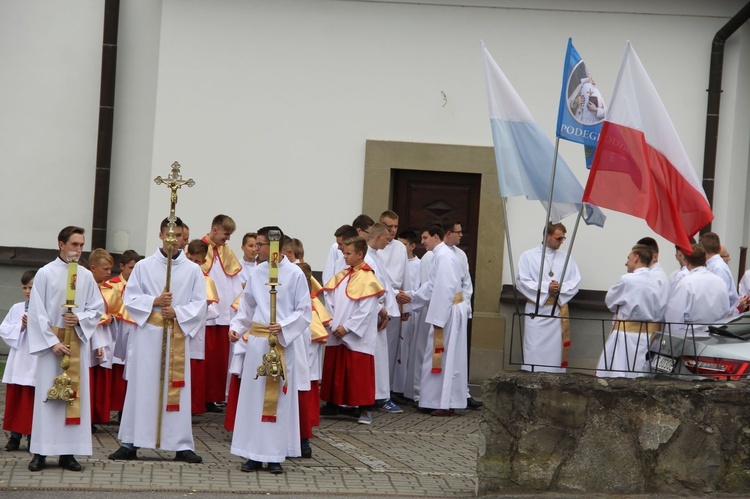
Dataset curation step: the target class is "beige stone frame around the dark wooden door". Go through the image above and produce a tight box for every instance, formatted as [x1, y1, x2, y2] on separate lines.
[362, 140, 505, 383]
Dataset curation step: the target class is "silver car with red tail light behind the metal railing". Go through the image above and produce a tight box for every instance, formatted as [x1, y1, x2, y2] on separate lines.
[649, 313, 750, 380]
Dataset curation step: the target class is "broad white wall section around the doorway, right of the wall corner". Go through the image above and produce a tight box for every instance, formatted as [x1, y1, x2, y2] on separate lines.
[129, 1, 739, 289]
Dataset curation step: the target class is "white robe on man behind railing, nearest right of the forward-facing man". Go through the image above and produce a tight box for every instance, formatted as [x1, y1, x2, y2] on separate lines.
[596, 267, 661, 378]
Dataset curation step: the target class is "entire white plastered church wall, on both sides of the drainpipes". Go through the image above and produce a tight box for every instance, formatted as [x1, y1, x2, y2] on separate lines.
[0, 0, 750, 296]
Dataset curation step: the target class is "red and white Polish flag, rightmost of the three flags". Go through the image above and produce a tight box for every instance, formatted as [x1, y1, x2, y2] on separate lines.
[583, 42, 714, 252]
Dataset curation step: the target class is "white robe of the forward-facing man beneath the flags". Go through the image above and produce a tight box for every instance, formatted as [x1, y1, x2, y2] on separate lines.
[516, 244, 581, 373]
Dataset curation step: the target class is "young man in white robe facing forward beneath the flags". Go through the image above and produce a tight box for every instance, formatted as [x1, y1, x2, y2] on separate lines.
[516, 223, 581, 373]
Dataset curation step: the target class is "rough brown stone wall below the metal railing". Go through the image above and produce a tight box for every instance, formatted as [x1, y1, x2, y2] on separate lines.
[477, 371, 750, 495]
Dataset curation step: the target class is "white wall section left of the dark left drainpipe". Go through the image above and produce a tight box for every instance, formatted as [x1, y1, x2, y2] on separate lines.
[0, 0, 104, 248]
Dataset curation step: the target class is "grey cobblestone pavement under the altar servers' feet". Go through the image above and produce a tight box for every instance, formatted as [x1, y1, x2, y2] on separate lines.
[0, 385, 480, 497]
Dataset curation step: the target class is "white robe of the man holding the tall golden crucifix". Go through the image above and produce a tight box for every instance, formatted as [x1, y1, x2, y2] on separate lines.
[119, 249, 206, 451]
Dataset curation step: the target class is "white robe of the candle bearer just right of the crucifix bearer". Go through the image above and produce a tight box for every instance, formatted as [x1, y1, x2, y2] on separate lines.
[230, 258, 312, 463]
